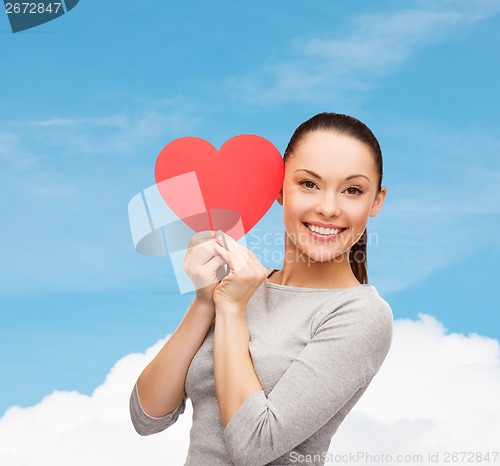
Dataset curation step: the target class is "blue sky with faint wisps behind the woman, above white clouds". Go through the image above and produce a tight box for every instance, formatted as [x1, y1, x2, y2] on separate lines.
[0, 0, 500, 415]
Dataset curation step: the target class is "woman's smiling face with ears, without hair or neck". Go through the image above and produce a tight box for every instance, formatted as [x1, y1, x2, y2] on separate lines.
[277, 131, 385, 262]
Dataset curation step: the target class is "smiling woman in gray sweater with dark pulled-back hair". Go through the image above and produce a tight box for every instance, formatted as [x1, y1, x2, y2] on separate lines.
[131, 113, 393, 466]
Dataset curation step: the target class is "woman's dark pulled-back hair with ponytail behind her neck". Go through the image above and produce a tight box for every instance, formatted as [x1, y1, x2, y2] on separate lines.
[283, 112, 383, 283]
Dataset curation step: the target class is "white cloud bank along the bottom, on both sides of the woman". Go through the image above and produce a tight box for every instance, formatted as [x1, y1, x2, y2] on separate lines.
[0, 314, 500, 466]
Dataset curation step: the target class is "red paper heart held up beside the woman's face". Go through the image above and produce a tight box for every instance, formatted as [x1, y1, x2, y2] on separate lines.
[155, 134, 285, 240]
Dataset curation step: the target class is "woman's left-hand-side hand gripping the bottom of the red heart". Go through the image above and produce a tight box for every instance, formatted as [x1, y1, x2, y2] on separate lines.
[184, 231, 226, 305]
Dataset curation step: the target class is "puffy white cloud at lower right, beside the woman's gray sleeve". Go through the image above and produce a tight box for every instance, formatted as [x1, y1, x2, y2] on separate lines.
[331, 314, 500, 464]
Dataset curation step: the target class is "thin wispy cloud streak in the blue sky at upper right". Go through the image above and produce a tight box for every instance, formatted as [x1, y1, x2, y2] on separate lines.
[228, 0, 500, 104]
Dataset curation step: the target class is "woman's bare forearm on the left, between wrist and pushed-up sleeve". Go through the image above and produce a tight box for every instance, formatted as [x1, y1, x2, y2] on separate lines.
[137, 298, 215, 417]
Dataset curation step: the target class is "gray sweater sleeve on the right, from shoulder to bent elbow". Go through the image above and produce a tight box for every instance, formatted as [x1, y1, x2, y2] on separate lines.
[224, 299, 393, 466]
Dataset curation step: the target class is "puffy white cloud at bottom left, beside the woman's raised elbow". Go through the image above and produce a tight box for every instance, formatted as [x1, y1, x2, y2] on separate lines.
[0, 342, 191, 466]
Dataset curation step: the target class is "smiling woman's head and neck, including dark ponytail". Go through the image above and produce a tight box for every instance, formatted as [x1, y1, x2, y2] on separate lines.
[275, 113, 386, 288]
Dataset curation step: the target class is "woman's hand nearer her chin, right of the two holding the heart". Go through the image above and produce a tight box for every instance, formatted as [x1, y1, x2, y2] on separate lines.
[213, 235, 269, 307]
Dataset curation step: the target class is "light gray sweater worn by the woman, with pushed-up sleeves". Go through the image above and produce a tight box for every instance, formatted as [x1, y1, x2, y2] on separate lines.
[130, 274, 393, 466]
